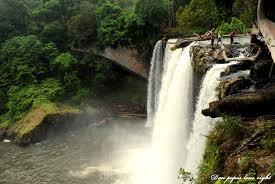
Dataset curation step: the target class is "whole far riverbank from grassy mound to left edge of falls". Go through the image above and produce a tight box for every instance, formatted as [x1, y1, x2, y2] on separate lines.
[0, 75, 146, 146]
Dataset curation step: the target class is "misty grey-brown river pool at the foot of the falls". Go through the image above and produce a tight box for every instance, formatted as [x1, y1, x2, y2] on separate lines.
[0, 119, 150, 184]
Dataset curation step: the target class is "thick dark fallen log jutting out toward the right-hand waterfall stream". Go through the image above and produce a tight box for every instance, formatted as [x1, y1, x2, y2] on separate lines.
[202, 86, 275, 118]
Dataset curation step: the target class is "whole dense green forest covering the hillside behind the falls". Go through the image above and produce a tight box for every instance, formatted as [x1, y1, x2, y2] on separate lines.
[0, 0, 257, 125]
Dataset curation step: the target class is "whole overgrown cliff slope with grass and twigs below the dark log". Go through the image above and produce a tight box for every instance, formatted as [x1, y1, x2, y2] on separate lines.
[197, 116, 275, 184]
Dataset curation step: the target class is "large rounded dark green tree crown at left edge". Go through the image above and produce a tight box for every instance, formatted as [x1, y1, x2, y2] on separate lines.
[0, 36, 53, 85]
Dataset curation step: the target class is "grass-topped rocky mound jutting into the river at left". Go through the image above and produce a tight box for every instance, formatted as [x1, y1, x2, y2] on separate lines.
[8, 103, 80, 145]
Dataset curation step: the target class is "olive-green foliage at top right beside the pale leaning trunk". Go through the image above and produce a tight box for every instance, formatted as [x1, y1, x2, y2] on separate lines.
[233, 0, 258, 26]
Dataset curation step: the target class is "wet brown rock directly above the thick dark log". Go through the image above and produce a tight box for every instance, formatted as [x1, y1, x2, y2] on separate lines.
[218, 77, 252, 99]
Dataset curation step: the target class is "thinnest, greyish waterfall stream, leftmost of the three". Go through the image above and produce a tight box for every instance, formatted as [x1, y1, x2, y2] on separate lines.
[146, 40, 163, 127]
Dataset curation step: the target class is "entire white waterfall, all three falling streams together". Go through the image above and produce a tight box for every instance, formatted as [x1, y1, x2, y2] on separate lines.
[146, 40, 237, 184]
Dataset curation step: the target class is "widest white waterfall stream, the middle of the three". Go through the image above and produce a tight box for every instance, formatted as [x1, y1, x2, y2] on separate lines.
[150, 44, 193, 184]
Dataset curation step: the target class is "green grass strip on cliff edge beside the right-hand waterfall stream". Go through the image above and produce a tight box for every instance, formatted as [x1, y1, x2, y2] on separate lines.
[196, 116, 245, 184]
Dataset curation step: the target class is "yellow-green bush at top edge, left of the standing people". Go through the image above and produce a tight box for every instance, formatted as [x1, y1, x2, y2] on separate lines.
[176, 0, 218, 33]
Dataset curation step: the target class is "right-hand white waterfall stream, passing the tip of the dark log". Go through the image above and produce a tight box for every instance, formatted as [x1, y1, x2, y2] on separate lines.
[182, 62, 238, 176]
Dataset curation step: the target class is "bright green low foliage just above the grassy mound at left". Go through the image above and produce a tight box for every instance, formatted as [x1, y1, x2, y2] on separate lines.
[7, 79, 62, 121]
